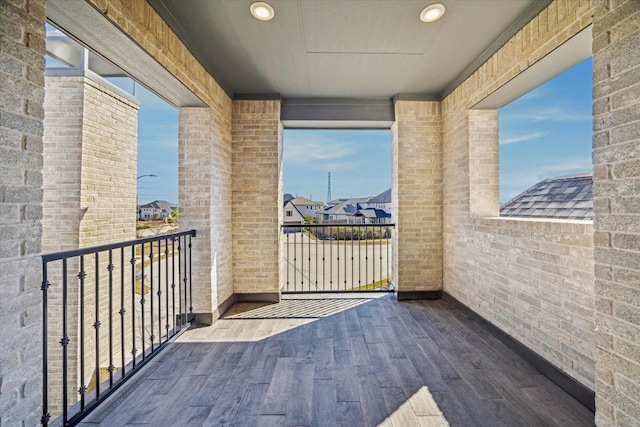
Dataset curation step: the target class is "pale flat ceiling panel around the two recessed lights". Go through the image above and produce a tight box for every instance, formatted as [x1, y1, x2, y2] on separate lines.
[149, 0, 549, 98]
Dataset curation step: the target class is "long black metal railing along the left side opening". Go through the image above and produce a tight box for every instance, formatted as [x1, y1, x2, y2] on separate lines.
[41, 230, 196, 426]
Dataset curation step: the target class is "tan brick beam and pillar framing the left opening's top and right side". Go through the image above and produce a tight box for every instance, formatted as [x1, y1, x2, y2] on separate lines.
[87, 0, 238, 318]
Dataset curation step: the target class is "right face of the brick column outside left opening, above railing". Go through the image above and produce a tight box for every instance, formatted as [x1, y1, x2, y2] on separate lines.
[80, 79, 139, 247]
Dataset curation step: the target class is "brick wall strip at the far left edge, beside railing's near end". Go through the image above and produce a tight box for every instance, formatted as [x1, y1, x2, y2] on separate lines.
[0, 0, 45, 426]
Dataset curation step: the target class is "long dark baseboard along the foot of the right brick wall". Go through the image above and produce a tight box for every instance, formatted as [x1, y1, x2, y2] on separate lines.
[442, 292, 596, 412]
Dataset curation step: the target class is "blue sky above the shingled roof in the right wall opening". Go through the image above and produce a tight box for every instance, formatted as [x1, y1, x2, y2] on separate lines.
[499, 58, 593, 203]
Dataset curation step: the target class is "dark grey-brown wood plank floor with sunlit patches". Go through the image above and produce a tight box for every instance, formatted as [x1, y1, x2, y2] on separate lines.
[81, 294, 594, 427]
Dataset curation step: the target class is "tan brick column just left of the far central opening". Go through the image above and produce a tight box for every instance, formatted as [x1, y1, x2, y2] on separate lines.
[231, 101, 282, 301]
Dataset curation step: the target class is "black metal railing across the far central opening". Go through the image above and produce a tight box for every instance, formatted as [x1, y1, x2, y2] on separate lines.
[282, 223, 395, 293]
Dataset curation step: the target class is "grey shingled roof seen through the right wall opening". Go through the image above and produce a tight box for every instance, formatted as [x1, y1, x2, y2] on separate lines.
[500, 174, 593, 220]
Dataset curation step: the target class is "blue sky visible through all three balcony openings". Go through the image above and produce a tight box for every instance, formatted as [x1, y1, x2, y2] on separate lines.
[127, 58, 592, 203]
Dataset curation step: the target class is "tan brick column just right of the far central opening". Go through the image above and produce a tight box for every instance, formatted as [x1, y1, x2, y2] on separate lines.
[392, 101, 442, 299]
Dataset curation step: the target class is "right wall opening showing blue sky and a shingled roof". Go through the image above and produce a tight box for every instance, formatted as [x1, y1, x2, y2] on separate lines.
[499, 58, 593, 220]
